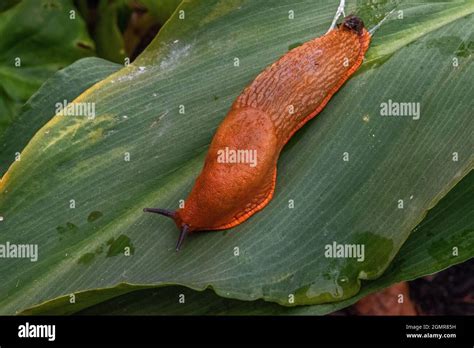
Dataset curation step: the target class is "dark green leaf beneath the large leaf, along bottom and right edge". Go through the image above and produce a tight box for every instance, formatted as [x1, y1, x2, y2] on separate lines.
[22, 172, 474, 315]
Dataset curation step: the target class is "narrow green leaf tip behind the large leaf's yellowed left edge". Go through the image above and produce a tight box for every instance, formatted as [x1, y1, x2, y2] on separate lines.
[0, 57, 122, 175]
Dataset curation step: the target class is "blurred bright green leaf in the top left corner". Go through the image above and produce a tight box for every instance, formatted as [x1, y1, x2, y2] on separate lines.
[0, 0, 94, 135]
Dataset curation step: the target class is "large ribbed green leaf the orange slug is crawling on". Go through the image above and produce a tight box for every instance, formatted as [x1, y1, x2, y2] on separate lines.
[0, 0, 474, 313]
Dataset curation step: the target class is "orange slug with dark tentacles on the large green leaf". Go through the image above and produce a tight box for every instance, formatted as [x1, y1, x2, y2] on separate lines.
[144, 15, 371, 250]
